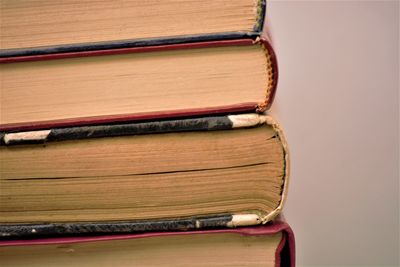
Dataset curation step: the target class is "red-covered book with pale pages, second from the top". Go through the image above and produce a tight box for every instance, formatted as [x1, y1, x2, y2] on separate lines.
[0, 39, 278, 131]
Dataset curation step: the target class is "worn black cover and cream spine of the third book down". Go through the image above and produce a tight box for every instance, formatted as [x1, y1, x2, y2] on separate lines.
[0, 114, 289, 238]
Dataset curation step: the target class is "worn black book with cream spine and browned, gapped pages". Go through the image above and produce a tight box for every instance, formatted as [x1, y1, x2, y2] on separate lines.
[0, 114, 289, 237]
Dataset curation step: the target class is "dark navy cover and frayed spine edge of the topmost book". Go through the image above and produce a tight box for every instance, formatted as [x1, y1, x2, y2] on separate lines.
[0, 0, 266, 58]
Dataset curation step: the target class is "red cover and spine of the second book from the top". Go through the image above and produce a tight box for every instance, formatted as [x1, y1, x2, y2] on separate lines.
[0, 38, 278, 132]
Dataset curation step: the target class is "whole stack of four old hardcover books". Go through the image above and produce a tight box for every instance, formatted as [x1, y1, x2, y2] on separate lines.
[0, 0, 295, 266]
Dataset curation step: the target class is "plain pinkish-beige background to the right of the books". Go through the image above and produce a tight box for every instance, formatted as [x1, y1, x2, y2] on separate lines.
[266, 1, 399, 266]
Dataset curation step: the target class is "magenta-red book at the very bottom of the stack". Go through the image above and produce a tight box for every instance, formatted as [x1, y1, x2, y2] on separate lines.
[0, 222, 295, 267]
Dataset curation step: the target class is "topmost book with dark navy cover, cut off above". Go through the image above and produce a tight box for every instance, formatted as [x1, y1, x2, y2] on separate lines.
[0, 0, 266, 57]
